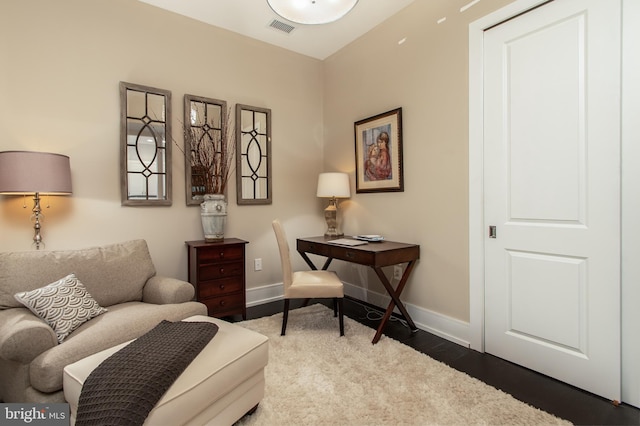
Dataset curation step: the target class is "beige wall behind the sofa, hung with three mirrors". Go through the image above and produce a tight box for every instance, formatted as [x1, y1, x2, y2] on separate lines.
[0, 0, 324, 287]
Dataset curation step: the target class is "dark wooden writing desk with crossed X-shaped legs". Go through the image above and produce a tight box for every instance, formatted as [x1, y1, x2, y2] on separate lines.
[296, 237, 420, 344]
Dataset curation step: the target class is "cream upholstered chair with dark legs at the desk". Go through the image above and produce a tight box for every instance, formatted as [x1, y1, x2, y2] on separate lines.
[273, 219, 344, 336]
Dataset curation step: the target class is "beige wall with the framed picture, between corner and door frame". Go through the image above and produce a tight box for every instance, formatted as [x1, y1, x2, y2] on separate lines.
[324, 0, 510, 321]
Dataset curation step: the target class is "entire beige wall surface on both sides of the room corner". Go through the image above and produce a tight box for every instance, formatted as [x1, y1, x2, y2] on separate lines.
[0, 0, 510, 321]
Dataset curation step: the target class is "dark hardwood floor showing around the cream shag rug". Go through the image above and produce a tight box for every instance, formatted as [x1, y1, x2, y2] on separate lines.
[239, 298, 640, 425]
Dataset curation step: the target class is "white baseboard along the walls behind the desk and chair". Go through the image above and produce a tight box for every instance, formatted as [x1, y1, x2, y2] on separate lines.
[247, 283, 470, 348]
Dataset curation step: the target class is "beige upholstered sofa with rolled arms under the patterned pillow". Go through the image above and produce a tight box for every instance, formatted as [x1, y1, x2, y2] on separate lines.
[0, 240, 207, 402]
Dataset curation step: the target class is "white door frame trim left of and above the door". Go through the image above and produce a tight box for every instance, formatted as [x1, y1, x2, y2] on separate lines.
[469, 0, 549, 352]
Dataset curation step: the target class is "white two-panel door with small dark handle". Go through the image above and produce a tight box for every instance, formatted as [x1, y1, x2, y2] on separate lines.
[484, 0, 620, 400]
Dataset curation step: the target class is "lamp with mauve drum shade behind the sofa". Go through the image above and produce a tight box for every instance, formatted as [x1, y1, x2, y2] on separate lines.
[0, 151, 71, 249]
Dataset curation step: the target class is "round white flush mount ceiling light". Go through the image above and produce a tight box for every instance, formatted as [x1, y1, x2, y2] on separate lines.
[267, 0, 358, 25]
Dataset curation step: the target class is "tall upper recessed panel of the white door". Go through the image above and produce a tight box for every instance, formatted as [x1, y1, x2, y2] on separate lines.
[504, 15, 586, 221]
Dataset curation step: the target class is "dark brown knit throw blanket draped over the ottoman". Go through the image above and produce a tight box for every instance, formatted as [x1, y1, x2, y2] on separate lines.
[76, 321, 218, 426]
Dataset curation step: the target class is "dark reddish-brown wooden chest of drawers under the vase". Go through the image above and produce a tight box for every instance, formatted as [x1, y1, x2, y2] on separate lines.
[186, 238, 248, 319]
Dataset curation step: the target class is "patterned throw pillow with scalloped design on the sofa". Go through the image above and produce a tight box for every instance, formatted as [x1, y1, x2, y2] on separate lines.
[14, 274, 107, 343]
